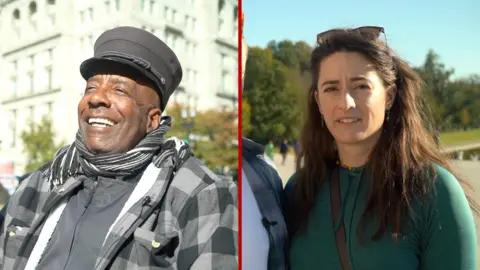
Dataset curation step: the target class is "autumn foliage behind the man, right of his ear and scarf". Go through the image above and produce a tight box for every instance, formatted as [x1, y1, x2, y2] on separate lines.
[167, 104, 238, 171]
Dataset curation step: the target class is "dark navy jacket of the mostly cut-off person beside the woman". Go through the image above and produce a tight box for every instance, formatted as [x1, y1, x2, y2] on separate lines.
[242, 138, 288, 270]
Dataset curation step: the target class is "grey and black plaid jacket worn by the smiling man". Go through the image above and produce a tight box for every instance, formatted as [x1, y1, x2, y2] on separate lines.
[0, 158, 238, 270]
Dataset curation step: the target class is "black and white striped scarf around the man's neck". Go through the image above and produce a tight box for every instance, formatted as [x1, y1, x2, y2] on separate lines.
[44, 116, 191, 189]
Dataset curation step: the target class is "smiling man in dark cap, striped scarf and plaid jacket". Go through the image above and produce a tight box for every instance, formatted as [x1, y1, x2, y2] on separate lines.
[0, 27, 238, 270]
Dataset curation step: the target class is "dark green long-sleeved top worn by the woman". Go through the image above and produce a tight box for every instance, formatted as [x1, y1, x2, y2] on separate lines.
[285, 167, 477, 270]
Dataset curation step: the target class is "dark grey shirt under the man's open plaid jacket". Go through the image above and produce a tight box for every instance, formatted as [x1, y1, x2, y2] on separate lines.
[36, 175, 141, 270]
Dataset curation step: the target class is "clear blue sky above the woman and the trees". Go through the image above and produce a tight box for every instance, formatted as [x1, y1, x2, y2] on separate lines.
[242, 0, 480, 77]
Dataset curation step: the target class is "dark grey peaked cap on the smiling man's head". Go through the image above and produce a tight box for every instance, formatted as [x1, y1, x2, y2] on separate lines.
[80, 26, 183, 110]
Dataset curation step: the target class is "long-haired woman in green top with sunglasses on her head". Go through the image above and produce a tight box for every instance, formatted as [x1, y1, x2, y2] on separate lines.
[286, 27, 477, 270]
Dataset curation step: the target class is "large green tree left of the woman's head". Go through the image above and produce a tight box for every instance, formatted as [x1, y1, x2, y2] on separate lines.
[243, 47, 300, 143]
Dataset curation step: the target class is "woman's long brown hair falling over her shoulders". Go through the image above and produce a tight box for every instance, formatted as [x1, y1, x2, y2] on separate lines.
[287, 30, 478, 239]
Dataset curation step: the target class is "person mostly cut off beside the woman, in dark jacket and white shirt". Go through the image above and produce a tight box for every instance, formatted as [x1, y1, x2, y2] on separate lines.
[241, 14, 287, 270]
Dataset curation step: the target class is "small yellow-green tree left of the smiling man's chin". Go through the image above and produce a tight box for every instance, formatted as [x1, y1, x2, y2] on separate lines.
[21, 116, 63, 172]
